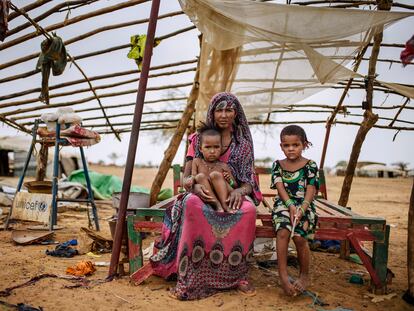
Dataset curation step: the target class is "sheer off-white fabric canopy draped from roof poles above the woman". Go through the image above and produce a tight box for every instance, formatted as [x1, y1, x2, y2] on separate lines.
[179, 0, 414, 120]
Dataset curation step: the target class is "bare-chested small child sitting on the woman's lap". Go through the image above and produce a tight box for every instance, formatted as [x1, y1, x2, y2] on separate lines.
[184, 124, 235, 212]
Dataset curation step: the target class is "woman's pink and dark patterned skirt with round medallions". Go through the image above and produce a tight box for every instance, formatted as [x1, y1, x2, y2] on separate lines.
[151, 194, 256, 300]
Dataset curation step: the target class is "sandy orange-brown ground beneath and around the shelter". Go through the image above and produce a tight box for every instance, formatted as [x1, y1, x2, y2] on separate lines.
[0, 166, 414, 311]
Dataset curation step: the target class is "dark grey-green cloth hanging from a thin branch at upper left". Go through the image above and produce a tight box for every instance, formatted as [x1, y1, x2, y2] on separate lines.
[36, 33, 67, 105]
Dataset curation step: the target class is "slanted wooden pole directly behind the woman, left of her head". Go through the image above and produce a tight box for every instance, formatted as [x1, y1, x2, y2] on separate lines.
[150, 43, 200, 205]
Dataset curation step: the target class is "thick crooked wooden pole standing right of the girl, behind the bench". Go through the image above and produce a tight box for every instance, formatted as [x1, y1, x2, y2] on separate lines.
[338, 0, 392, 210]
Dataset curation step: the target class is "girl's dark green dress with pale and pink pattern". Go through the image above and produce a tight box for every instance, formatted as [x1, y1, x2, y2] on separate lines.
[270, 160, 319, 237]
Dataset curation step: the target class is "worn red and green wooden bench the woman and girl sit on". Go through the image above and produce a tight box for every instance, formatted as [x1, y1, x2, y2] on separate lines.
[127, 165, 390, 291]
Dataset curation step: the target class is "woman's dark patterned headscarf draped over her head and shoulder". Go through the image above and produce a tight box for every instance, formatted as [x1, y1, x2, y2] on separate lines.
[195, 92, 261, 204]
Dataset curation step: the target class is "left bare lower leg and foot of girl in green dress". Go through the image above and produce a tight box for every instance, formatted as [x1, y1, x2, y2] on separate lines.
[276, 229, 296, 296]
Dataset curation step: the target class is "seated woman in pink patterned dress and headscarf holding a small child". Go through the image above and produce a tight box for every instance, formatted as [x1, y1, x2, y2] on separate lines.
[151, 93, 262, 300]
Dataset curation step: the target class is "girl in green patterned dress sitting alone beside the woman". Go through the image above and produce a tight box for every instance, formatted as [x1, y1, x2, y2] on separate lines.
[270, 125, 318, 296]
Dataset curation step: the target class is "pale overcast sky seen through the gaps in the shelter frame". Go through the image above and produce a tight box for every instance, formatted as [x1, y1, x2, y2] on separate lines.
[0, 0, 414, 168]
